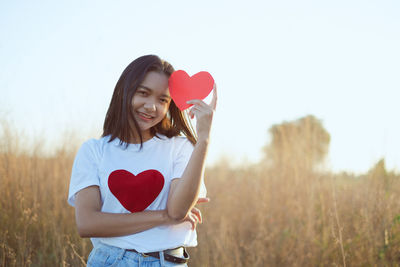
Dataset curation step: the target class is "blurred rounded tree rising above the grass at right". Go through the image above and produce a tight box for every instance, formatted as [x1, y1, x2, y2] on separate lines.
[264, 115, 330, 174]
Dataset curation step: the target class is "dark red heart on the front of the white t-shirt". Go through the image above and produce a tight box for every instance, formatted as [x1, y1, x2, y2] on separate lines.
[108, 170, 164, 212]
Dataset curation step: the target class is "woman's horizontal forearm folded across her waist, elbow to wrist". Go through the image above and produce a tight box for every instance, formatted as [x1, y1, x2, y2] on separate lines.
[76, 210, 170, 237]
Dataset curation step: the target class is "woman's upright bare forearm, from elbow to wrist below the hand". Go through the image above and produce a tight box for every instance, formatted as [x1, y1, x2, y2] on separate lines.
[167, 139, 208, 220]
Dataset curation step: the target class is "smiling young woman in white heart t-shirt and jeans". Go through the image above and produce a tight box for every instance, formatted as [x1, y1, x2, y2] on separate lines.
[68, 55, 217, 266]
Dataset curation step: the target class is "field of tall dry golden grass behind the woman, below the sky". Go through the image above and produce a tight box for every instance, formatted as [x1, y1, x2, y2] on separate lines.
[0, 118, 400, 266]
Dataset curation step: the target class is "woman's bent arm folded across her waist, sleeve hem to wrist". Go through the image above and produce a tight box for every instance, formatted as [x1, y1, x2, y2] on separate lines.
[75, 186, 170, 237]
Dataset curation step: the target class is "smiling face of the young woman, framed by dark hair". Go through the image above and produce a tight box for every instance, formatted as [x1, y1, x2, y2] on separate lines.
[132, 71, 171, 141]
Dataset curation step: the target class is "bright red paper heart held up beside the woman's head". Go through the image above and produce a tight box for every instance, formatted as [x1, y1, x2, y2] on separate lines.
[168, 70, 214, 110]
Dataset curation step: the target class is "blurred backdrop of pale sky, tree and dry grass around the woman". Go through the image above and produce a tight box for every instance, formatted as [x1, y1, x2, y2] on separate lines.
[0, 0, 400, 266]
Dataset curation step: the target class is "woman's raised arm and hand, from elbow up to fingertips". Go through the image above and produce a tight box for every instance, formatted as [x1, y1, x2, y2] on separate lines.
[167, 85, 217, 220]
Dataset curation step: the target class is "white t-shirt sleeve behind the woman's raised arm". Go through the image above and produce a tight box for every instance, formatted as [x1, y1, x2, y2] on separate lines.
[172, 139, 207, 197]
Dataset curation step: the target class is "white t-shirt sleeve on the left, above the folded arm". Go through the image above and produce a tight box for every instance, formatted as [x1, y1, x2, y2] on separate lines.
[68, 139, 100, 207]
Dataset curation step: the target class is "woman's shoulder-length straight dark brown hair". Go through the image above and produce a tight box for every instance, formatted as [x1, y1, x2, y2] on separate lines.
[102, 55, 196, 147]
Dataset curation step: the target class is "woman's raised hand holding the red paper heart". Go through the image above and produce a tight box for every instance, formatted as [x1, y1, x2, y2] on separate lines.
[187, 83, 217, 143]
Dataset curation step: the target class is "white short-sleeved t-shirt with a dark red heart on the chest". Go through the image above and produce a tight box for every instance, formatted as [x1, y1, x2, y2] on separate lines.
[68, 135, 206, 252]
